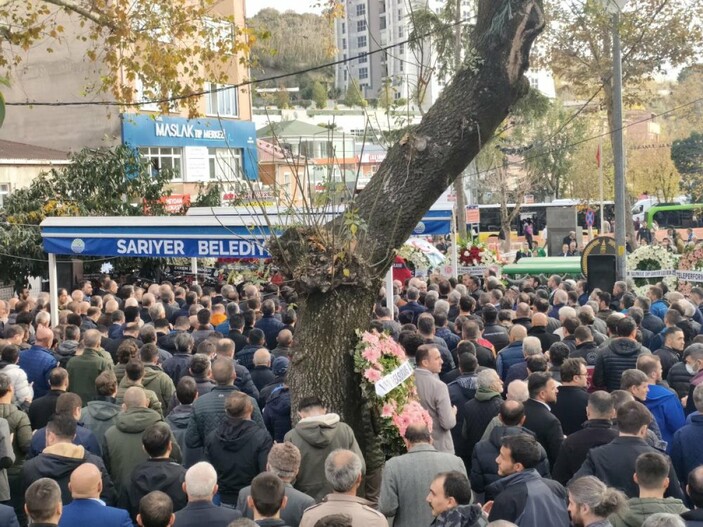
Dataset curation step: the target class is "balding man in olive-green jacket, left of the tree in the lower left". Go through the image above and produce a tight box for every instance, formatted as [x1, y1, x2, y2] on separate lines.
[103, 386, 182, 495]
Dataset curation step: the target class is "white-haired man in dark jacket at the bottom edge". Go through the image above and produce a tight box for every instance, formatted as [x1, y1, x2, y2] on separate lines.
[173, 461, 242, 527]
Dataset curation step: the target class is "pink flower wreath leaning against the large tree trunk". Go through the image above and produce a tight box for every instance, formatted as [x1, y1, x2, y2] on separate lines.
[354, 331, 432, 458]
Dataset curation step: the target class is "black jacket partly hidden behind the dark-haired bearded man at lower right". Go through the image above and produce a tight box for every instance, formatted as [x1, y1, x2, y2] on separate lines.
[469, 426, 549, 501]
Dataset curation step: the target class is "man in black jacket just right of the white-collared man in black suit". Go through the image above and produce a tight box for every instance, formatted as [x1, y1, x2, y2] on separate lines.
[552, 358, 588, 436]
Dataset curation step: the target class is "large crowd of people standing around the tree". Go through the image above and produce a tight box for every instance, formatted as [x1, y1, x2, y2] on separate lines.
[0, 275, 703, 527]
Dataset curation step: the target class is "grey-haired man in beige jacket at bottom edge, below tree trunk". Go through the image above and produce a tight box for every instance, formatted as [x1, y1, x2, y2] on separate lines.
[300, 449, 388, 527]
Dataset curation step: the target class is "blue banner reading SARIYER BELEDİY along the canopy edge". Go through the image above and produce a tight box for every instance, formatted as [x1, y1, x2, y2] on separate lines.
[44, 237, 270, 258]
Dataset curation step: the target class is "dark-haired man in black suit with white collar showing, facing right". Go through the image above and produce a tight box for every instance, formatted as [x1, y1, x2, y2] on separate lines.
[523, 372, 564, 466]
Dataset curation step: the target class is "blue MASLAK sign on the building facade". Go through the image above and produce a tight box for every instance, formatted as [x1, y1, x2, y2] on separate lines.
[121, 113, 258, 180]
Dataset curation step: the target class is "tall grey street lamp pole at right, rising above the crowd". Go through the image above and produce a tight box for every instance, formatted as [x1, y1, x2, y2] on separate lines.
[602, 0, 629, 280]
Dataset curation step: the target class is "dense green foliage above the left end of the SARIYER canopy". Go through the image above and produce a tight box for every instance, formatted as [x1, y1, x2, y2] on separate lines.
[0, 146, 173, 284]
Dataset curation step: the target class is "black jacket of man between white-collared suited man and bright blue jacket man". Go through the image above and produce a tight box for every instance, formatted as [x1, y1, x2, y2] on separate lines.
[552, 419, 618, 485]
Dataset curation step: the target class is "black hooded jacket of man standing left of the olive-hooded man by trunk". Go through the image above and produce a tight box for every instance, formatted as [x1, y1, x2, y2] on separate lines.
[205, 417, 273, 505]
